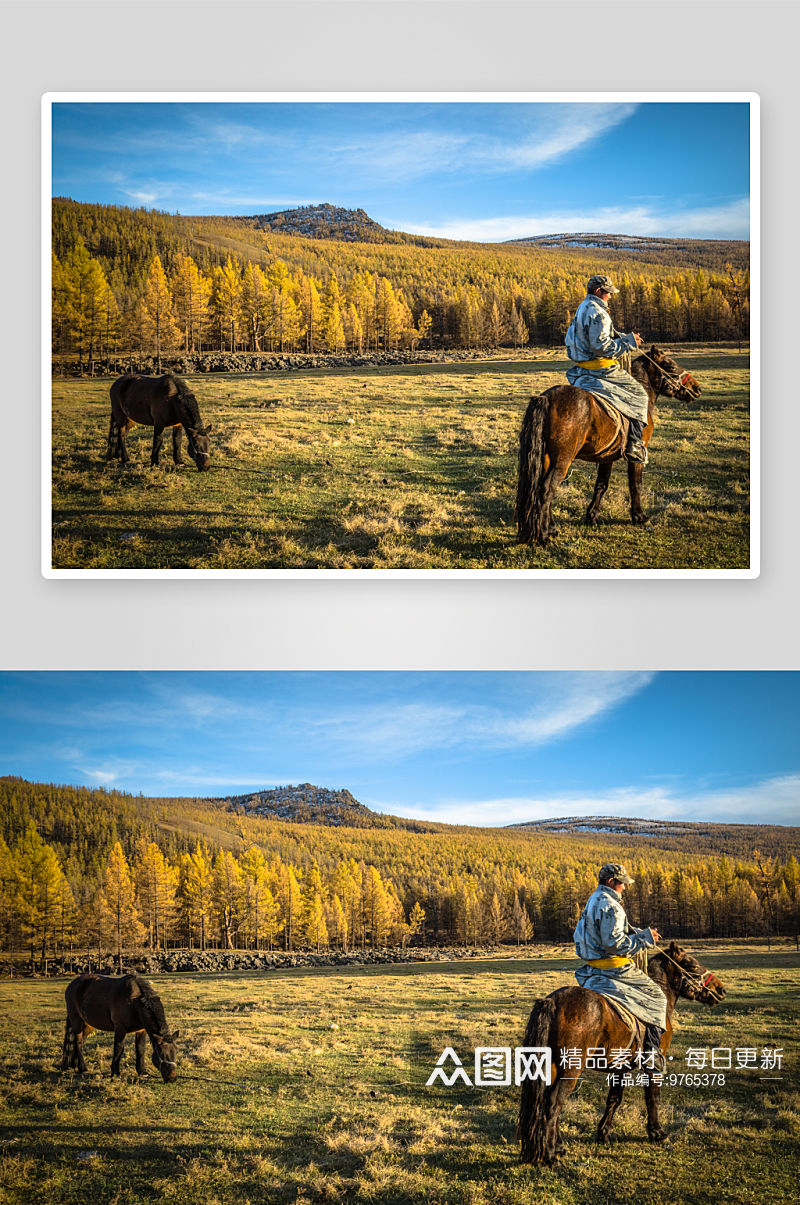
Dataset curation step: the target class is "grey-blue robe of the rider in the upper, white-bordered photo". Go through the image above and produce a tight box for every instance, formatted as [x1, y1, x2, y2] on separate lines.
[564, 293, 647, 423]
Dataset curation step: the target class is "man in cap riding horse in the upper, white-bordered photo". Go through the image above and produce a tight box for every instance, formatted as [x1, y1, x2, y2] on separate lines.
[564, 276, 647, 464]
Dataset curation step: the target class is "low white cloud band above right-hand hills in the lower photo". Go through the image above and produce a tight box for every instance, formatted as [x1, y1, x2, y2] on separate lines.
[390, 775, 800, 828]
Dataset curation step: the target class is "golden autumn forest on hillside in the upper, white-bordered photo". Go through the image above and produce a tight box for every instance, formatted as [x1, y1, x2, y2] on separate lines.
[52, 198, 749, 370]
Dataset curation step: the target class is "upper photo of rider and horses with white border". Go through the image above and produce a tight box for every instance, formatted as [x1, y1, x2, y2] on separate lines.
[42, 93, 760, 578]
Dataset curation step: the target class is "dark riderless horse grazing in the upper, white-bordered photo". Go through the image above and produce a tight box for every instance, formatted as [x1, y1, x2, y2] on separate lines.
[106, 372, 211, 470]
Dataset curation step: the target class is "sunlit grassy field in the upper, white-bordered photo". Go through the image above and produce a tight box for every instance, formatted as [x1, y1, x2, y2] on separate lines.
[53, 345, 749, 570]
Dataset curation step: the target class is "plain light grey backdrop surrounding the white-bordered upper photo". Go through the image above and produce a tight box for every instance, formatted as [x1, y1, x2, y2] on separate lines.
[0, 0, 800, 670]
